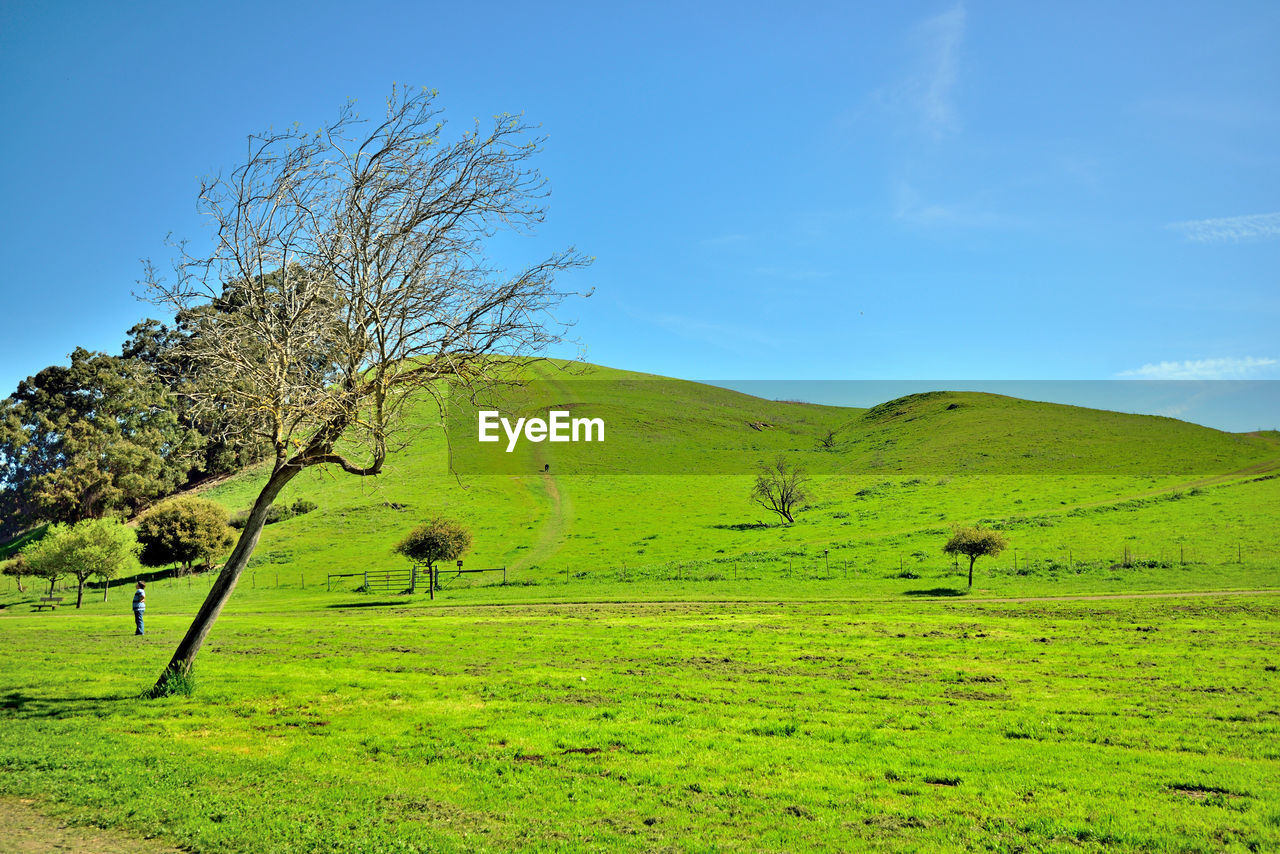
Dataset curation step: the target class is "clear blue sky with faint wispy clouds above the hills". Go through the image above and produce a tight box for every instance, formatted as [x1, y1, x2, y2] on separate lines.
[0, 0, 1280, 426]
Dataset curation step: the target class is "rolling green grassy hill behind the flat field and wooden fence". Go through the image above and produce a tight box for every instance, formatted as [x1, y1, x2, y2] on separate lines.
[154, 366, 1280, 601]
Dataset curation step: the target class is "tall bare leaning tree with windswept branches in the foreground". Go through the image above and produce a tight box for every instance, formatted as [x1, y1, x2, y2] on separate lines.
[143, 90, 589, 695]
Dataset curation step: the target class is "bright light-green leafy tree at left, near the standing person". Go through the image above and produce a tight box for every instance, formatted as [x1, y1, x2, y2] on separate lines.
[22, 519, 140, 608]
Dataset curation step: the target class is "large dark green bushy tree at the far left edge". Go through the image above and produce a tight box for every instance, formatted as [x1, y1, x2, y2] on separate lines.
[0, 348, 201, 531]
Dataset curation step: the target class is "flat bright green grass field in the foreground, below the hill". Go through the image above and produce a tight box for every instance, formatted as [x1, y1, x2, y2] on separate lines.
[0, 594, 1280, 851]
